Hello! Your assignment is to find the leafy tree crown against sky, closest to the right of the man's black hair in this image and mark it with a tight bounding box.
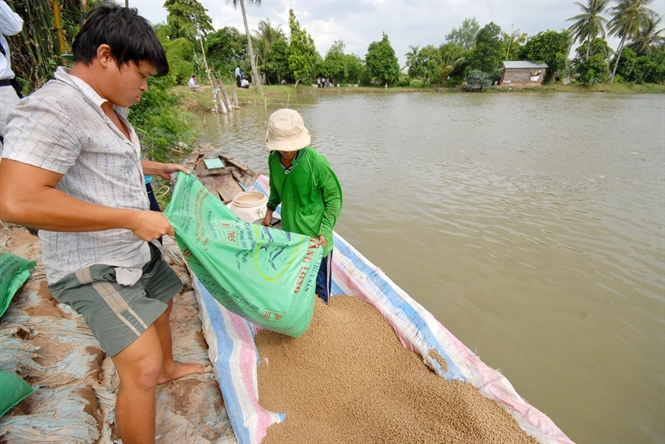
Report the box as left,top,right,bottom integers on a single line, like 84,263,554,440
164,0,213,42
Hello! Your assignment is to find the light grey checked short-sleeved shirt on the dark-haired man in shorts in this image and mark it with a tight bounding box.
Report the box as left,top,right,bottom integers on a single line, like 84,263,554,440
2,67,150,284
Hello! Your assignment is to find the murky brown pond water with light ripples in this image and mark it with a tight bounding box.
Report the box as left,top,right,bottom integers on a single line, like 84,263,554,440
193,93,665,442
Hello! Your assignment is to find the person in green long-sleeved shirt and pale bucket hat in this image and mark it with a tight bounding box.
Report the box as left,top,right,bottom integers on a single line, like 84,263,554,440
263,109,342,304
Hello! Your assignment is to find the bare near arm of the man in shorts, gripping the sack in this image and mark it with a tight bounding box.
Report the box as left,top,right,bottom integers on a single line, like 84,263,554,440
0,159,174,241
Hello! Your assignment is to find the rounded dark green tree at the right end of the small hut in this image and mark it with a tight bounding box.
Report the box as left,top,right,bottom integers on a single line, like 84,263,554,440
520,30,571,82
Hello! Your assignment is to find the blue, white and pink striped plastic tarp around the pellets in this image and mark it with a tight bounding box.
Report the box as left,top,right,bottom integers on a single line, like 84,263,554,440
193,176,572,444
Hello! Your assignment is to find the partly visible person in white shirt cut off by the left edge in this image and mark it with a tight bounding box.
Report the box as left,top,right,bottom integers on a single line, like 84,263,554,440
0,0,23,138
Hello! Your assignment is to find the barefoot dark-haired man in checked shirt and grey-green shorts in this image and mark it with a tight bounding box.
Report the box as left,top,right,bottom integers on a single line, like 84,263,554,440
0,2,203,444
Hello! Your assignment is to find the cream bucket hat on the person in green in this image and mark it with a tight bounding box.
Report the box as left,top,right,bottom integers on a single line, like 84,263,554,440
266,108,312,151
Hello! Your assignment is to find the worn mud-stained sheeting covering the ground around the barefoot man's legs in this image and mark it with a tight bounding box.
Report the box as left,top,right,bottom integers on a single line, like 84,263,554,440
0,225,237,444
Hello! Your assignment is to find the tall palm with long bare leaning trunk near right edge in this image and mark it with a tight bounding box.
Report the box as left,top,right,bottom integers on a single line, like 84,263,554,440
608,0,658,83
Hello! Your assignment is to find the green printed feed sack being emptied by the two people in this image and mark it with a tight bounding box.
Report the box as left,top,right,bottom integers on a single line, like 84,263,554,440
165,172,322,338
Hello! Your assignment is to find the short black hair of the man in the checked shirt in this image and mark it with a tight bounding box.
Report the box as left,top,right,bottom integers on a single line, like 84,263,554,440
72,2,169,77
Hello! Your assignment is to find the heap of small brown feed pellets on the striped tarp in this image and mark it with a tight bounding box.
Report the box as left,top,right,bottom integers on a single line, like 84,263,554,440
256,296,536,444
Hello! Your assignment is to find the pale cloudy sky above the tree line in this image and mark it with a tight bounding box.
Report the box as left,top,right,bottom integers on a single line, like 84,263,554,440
128,0,665,66
